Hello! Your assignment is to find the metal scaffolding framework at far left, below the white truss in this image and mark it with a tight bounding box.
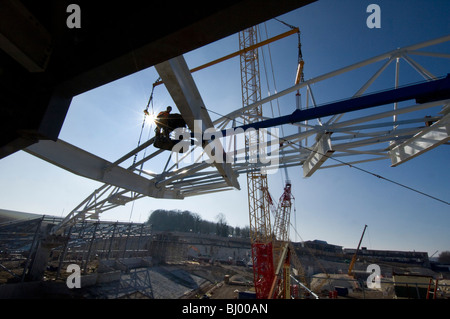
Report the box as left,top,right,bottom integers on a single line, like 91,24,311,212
0,216,153,284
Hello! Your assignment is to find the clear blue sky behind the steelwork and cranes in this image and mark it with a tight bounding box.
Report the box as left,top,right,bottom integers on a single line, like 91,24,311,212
0,0,450,254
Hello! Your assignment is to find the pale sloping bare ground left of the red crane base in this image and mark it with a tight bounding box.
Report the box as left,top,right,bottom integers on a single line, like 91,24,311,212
78,261,253,299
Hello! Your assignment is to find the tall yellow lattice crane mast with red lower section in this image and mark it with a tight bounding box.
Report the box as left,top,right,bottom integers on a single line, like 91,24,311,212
239,26,274,299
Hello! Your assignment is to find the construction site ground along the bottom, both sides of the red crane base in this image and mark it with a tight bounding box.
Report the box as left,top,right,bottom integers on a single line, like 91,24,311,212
0,221,450,299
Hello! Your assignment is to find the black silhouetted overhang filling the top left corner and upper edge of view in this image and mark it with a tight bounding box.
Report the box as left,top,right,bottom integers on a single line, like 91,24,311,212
0,0,316,158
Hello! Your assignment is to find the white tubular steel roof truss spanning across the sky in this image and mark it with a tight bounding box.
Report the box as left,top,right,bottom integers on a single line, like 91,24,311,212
27,35,450,233
